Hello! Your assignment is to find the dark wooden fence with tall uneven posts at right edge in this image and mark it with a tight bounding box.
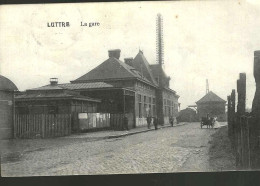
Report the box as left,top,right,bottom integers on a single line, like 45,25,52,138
228,73,260,169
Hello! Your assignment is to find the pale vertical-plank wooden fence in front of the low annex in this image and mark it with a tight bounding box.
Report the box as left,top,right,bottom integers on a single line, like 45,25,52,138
14,114,71,138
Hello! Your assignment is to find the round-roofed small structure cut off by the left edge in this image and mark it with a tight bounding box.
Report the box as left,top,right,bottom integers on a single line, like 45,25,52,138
0,75,18,140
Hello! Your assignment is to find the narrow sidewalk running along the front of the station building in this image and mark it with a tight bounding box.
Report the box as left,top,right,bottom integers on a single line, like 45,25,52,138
62,122,187,140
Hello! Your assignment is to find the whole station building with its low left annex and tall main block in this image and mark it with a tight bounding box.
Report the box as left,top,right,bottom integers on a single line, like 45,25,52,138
16,49,179,128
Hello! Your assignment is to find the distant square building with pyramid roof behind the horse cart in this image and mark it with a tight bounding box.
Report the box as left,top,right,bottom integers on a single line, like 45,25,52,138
196,91,227,121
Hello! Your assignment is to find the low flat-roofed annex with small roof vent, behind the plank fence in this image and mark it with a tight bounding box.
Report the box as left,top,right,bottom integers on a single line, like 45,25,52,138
15,78,101,132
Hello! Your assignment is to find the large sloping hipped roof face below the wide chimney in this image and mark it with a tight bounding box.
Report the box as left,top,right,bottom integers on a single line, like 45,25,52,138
72,57,138,83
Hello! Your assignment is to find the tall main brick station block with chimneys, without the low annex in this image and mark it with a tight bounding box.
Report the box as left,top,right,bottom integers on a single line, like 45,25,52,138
71,49,179,127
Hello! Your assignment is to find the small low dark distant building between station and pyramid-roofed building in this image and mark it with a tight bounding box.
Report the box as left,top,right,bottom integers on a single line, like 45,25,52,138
177,107,199,122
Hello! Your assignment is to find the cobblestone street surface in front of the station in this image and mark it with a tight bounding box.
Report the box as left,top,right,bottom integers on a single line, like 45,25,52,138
1,123,224,176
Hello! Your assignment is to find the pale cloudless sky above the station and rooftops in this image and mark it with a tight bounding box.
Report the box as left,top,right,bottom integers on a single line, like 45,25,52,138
0,0,260,109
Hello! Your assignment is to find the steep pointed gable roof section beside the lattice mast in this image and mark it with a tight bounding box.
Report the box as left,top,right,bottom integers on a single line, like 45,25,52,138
132,51,157,85
